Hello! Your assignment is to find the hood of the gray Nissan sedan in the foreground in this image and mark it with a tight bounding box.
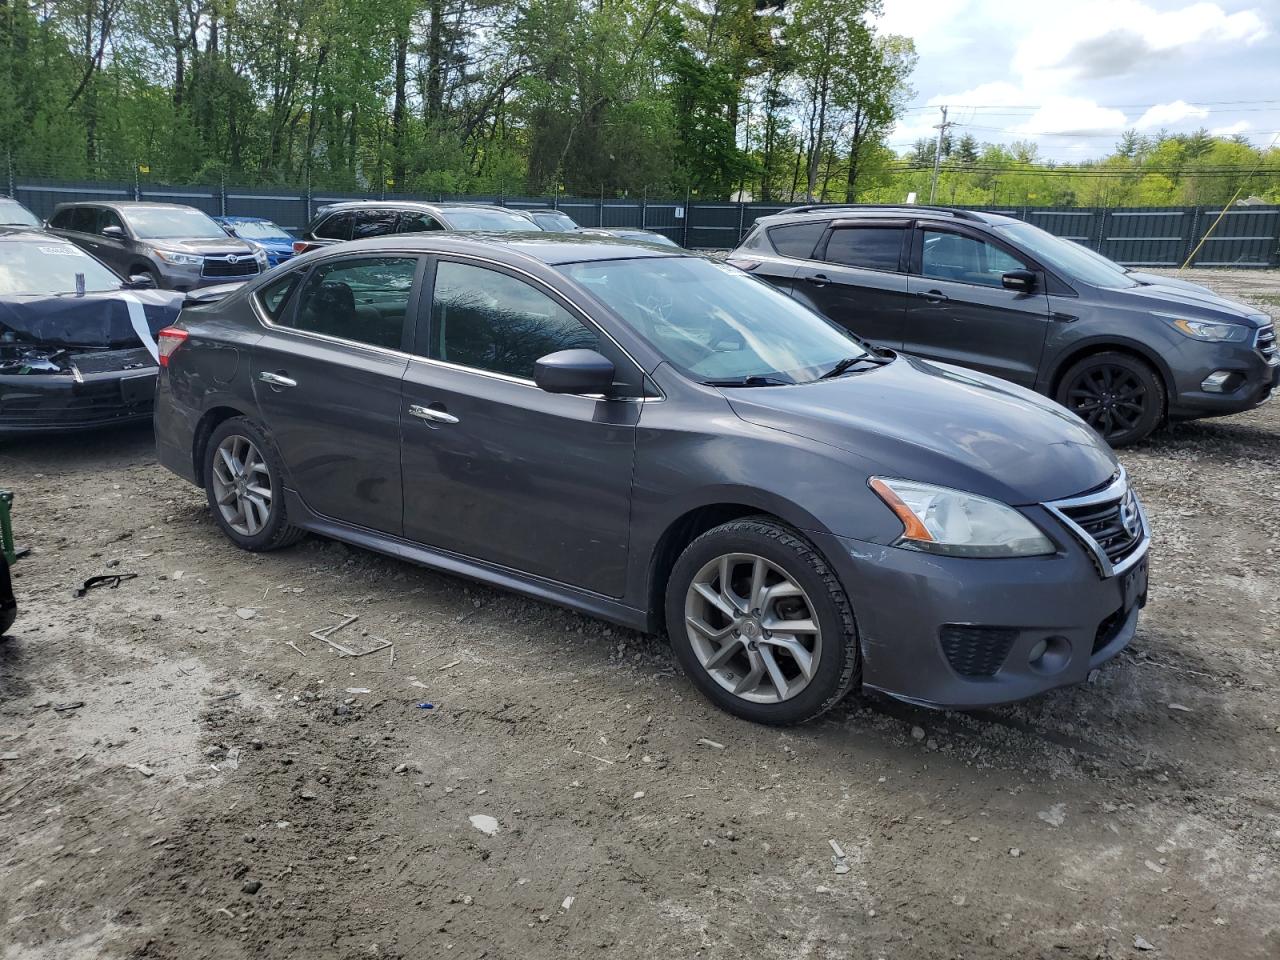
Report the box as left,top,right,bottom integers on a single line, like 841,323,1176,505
722,356,1120,506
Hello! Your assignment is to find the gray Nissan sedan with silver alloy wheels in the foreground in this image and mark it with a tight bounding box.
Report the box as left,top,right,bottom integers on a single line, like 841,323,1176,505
155,234,1148,723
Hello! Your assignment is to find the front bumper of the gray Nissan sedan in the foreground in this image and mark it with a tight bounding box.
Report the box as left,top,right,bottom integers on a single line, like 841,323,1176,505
819,522,1149,709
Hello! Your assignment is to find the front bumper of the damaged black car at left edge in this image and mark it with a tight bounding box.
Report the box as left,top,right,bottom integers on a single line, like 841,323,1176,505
0,366,156,438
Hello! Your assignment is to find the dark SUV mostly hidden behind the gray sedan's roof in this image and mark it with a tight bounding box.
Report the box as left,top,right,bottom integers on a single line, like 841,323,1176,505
293,200,541,253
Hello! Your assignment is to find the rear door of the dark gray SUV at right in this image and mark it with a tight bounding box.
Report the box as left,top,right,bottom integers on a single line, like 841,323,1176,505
794,219,911,349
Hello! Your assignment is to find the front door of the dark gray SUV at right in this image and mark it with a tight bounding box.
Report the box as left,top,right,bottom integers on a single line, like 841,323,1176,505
902,223,1048,387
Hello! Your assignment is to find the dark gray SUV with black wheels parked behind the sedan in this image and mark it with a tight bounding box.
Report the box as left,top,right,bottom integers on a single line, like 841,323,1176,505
730,206,1280,447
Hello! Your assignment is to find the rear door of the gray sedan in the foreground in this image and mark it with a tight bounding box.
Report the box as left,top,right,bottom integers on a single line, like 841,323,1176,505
241,255,422,535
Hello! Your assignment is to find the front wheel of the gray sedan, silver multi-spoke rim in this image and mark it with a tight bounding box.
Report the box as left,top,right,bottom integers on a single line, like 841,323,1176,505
666,517,861,726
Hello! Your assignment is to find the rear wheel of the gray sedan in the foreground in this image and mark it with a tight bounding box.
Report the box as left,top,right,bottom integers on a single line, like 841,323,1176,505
204,417,303,552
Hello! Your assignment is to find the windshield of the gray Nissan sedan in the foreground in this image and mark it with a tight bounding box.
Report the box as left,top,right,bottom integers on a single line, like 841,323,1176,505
561,257,870,383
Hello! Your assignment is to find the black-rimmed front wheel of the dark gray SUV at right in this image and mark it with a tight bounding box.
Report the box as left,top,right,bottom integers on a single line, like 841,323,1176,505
1056,351,1165,448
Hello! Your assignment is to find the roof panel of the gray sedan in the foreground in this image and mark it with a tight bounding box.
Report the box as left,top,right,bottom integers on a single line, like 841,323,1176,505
307,230,692,266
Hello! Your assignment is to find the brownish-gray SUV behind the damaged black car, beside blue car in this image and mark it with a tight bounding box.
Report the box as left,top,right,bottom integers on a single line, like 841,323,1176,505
49,201,268,291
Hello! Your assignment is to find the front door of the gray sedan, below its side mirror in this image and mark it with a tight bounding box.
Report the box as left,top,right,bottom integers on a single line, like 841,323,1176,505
401,259,643,596
